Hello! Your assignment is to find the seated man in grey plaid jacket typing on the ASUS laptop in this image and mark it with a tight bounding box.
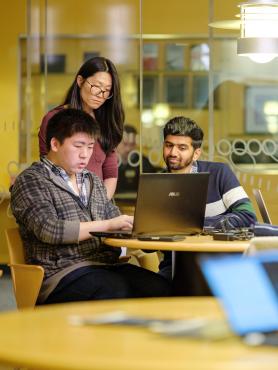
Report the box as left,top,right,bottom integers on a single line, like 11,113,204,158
11,109,170,304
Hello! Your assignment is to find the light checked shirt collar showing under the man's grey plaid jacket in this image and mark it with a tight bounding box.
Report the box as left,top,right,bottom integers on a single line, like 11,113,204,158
41,157,89,206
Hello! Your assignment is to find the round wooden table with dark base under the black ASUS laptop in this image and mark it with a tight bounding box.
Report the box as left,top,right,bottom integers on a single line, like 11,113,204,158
104,235,249,296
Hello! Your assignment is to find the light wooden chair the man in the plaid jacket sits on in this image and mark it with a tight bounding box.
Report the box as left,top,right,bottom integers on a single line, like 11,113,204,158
5,228,44,309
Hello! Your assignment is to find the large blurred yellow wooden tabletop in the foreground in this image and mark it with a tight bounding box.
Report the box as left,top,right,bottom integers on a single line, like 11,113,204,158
0,298,278,370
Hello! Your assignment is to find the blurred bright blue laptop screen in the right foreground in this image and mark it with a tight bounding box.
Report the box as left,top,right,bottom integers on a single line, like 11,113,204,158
200,252,278,335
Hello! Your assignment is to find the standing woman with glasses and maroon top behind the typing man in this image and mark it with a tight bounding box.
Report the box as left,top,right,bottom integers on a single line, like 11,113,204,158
39,57,124,199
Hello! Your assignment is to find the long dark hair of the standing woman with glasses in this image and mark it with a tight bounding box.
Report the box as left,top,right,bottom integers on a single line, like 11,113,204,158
63,57,125,153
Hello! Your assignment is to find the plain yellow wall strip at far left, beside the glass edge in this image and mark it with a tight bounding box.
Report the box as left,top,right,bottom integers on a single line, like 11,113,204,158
0,0,25,192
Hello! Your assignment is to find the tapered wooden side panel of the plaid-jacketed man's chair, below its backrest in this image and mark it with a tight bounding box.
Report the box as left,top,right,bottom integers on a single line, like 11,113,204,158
9,264,44,309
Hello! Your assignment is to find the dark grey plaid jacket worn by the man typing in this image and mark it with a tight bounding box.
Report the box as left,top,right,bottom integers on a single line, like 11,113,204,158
11,162,120,278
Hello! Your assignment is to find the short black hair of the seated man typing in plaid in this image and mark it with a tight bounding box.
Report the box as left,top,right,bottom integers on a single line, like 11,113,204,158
46,108,99,151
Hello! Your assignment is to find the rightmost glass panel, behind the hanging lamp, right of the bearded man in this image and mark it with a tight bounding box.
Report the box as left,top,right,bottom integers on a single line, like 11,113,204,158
210,0,278,223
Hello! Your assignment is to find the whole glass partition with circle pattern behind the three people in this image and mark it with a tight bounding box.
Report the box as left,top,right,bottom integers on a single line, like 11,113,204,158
16,0,278,221
